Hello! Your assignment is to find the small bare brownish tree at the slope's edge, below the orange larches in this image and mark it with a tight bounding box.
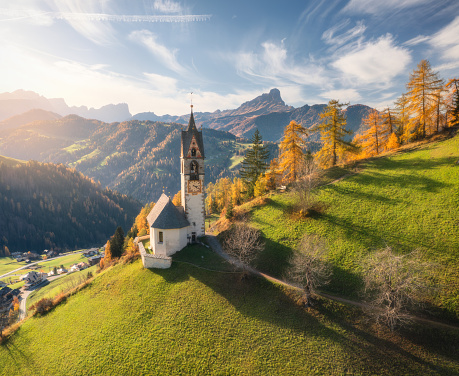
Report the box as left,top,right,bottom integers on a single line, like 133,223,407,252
293,155,322,217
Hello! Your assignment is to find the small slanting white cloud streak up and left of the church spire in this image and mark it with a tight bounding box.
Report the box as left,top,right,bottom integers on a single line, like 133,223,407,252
129,30,186,75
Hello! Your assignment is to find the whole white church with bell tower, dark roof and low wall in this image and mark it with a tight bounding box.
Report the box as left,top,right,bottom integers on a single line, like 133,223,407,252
139,107,205,268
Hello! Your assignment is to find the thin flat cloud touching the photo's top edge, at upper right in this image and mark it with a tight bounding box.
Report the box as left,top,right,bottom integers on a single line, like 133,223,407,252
343,0,430,15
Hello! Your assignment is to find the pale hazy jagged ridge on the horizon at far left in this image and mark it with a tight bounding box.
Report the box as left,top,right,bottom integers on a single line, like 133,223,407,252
0,90,132,122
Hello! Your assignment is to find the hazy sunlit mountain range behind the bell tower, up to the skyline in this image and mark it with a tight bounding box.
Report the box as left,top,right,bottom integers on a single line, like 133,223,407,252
0,89,371,203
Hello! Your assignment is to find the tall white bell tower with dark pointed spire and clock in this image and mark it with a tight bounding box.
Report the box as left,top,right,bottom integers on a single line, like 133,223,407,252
180,105,205,242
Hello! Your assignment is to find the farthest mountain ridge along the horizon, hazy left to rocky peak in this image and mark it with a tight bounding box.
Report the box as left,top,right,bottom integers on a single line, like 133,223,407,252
0,88,372,143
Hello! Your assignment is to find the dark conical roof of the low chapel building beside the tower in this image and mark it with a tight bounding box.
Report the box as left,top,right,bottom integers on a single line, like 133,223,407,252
147,193,190,230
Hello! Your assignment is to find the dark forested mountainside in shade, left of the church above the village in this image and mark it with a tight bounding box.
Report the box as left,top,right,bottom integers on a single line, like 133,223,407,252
0,158,141,253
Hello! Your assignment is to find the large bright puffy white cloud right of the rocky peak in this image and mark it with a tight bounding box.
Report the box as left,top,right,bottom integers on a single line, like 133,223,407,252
332,34,411,84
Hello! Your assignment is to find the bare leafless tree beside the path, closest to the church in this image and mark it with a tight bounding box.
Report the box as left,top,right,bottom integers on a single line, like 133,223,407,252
223,223,264,270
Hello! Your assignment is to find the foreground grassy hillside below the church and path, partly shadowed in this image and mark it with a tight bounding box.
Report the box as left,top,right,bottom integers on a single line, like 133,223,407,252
0,246,459,376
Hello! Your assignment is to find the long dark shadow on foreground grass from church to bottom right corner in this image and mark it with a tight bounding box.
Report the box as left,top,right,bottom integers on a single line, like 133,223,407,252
152,264,454,375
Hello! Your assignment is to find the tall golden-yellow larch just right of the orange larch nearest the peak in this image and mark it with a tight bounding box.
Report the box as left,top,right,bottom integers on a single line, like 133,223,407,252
314,99,354,167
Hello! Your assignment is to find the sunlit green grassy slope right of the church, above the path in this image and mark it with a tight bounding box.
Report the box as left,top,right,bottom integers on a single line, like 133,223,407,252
246,137,459,317
